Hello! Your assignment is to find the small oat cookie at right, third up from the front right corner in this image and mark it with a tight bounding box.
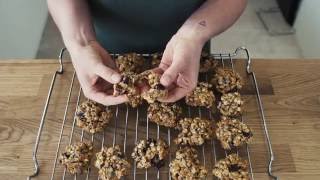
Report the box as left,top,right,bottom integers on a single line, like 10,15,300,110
218,92,244,117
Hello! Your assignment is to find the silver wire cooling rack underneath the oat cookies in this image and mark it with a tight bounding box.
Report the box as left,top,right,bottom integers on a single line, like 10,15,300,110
27,47,277,180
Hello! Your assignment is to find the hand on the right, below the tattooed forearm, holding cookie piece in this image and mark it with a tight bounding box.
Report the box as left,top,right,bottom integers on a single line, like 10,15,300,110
159,35,203,102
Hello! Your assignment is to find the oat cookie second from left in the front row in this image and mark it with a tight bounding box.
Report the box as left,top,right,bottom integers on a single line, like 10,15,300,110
95,145,130,180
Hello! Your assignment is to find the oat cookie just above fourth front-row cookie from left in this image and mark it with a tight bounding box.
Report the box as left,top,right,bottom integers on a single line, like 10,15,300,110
174,117,213,145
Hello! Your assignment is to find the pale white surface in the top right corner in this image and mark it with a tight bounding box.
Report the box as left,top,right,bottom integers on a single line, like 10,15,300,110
294,0,320,58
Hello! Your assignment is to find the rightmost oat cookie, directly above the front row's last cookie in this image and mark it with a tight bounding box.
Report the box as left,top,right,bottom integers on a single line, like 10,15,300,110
216,118,253,149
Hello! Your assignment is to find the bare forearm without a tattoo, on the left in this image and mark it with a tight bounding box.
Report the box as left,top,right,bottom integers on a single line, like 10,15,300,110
47,0,95,48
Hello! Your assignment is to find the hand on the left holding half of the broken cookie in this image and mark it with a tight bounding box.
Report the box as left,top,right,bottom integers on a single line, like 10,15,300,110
68,41,127,106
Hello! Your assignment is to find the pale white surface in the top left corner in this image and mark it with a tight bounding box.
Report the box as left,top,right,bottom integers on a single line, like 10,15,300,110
0,0,48,59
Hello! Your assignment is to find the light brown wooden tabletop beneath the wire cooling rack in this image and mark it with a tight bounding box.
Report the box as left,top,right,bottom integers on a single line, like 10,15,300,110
0,59,320,180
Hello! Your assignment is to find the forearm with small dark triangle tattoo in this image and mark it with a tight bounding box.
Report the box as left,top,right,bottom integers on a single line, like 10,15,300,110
177,0,247,44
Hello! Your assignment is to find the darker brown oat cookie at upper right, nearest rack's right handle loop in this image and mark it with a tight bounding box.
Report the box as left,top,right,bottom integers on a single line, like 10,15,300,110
211,68,243,94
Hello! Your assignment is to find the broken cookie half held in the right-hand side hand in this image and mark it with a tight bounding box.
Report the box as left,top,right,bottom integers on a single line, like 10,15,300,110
141,71,168,103
